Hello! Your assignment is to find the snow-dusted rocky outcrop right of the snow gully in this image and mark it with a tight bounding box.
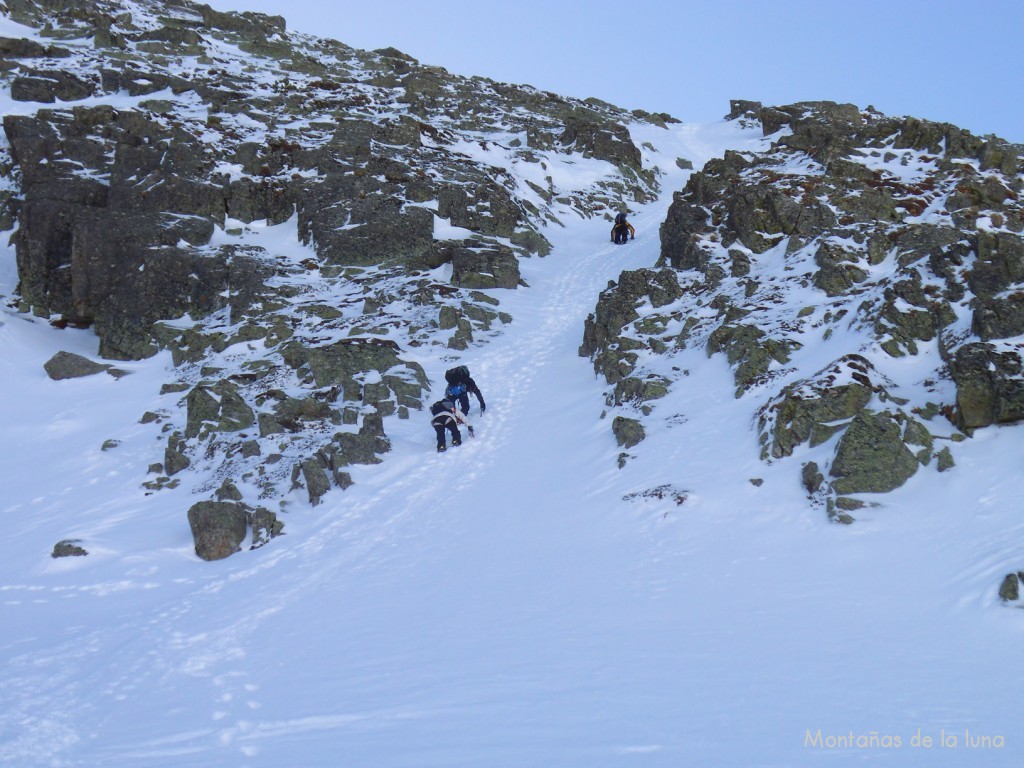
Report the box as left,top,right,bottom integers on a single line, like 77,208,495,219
580,101,1024,512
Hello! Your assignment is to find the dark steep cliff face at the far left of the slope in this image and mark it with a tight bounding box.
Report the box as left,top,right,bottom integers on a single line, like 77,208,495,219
4,108,267,359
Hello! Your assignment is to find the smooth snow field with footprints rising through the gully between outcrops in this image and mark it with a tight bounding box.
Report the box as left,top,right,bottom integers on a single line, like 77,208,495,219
0,114,1024,768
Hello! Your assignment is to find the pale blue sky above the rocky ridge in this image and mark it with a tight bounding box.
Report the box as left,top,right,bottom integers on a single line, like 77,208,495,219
208,0,1024,142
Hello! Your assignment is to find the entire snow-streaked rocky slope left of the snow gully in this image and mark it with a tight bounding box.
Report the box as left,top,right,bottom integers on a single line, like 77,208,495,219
0,0,669,557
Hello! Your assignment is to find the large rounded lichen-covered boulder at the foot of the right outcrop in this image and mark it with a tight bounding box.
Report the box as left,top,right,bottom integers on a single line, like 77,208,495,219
829,412,919,495
